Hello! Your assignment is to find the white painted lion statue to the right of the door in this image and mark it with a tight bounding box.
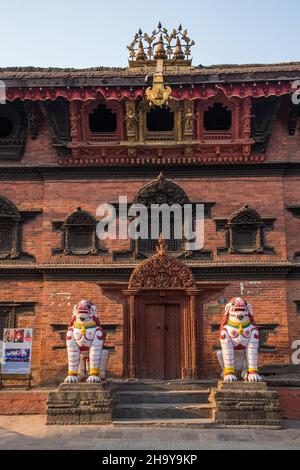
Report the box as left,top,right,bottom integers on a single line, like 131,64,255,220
218,298,263,382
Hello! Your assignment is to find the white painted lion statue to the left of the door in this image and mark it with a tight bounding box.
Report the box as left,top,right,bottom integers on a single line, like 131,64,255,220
65,300,108,384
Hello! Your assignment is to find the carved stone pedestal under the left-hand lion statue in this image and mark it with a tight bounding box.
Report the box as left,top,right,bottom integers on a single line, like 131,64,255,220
47,383,113,425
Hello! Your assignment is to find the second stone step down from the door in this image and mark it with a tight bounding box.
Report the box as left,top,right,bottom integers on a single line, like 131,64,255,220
115,389,210,405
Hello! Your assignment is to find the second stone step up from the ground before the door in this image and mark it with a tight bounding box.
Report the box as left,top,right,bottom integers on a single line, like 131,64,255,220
113,403,212,420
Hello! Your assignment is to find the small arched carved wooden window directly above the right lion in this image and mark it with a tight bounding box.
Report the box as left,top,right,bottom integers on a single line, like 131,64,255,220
226,206,264,254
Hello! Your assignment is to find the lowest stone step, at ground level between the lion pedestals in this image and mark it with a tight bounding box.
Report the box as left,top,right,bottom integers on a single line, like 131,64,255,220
113,418,214,429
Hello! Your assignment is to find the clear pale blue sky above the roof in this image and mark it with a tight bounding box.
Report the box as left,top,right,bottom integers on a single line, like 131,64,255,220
0,0,300,67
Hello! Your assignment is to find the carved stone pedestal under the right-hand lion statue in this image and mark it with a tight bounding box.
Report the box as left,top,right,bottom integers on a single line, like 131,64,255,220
210,382,281,426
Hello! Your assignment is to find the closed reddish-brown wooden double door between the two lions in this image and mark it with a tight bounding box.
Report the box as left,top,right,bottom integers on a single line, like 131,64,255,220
138,297,184,380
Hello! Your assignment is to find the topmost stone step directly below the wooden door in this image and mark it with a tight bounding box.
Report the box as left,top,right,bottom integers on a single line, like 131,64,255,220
107,380,217,392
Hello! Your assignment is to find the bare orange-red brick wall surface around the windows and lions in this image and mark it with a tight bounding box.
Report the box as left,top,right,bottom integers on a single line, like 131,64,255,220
0,105,300,383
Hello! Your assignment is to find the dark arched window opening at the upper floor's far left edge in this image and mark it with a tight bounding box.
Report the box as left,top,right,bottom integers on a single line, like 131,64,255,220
0,100,27,161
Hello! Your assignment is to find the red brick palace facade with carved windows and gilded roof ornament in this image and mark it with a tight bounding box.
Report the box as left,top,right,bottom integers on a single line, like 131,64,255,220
0,26,300,384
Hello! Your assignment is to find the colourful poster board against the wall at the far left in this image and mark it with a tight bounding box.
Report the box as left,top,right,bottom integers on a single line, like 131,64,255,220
2,328,32,374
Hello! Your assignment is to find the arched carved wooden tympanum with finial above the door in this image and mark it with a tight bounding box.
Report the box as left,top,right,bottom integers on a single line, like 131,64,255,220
129,237,196,290
